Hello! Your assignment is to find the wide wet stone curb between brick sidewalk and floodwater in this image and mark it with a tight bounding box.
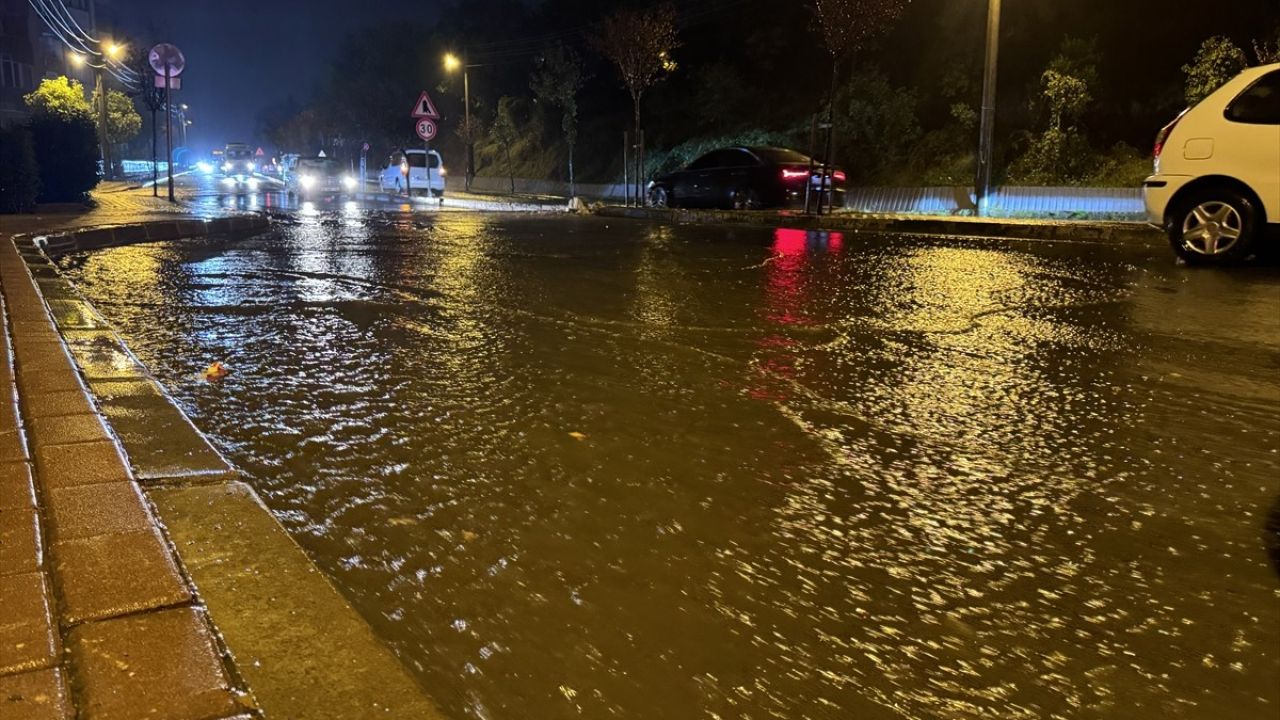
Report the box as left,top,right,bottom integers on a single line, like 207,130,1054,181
8,221,443,720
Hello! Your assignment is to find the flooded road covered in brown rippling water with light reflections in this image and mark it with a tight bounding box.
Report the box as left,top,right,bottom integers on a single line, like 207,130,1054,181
63,211,1280,719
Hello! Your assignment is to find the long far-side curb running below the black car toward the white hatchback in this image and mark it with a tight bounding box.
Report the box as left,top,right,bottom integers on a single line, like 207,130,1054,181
594,206,1165,245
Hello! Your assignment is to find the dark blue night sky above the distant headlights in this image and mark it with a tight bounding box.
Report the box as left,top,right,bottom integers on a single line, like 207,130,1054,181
111,0,435,151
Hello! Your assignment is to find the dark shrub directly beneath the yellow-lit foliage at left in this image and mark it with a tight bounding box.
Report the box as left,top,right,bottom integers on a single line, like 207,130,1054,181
31,114,99,202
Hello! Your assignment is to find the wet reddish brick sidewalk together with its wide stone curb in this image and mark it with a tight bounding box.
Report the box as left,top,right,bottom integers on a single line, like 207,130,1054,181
0,218,440,720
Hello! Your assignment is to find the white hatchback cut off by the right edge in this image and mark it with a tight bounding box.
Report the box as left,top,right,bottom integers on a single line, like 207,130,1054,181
1142,63,1280,264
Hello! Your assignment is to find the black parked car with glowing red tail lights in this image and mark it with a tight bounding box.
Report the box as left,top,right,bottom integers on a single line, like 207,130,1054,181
649,147,845,210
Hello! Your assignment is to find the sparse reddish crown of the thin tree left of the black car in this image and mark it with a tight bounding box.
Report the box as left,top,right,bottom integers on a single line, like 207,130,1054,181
594,3,680,196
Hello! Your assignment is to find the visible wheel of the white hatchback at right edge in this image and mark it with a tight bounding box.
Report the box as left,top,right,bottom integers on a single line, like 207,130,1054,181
1166,187,1258,265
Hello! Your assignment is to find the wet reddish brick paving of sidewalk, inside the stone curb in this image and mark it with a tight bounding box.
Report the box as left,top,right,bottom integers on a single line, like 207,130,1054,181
0,204,255,720
